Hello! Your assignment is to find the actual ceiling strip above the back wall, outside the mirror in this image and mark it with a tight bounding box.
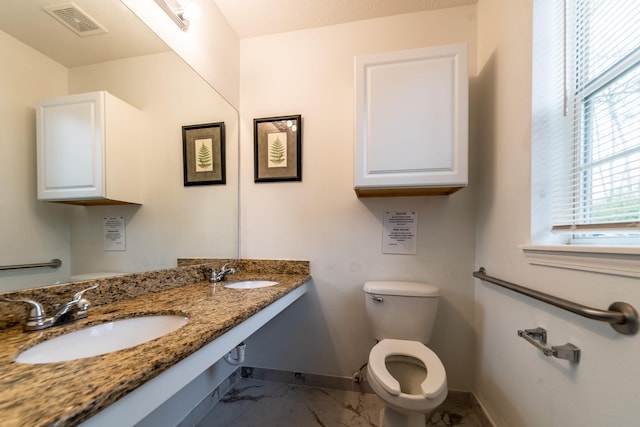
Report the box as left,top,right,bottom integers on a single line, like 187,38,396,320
212,0,478,38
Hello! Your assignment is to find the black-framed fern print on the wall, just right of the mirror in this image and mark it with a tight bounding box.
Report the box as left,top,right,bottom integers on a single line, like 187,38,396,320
253,114,302,182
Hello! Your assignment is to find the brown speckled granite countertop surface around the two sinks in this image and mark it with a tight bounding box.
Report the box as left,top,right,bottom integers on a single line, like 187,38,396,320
0,264,310,427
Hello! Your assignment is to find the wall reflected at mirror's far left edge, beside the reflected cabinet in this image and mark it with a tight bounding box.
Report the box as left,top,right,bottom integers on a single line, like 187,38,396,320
0,31,71,292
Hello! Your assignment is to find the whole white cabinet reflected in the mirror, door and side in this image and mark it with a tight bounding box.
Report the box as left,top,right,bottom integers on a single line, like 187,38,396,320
36,91,142,205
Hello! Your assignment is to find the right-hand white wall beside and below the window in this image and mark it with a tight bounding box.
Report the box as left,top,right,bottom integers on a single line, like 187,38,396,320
474,0,640,427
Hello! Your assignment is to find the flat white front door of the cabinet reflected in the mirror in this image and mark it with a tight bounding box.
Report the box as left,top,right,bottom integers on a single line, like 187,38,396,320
36,92,104,200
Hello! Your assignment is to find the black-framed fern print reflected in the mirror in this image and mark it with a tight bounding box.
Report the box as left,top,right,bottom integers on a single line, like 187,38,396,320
182,122,227,186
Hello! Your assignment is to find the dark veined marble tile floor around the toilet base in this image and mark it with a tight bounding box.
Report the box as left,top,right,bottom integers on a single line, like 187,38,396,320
196,378,482,427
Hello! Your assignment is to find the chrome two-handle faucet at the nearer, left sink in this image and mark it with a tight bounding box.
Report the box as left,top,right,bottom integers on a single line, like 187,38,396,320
0,283,98,332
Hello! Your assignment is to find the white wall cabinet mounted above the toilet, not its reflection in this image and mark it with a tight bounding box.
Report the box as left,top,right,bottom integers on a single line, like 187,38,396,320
354,44,469,197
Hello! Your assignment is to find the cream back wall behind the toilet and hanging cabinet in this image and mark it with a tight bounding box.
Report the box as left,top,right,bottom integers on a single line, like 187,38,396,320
240,6,476,390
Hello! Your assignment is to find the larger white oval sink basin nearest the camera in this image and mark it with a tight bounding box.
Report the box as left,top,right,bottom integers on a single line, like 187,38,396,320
15,315,189,364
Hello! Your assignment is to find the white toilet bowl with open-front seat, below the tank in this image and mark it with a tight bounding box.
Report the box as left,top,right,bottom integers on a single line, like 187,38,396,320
368,339,447,427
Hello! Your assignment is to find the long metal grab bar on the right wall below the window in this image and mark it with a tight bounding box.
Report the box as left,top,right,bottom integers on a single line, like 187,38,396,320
473,267,640,335
